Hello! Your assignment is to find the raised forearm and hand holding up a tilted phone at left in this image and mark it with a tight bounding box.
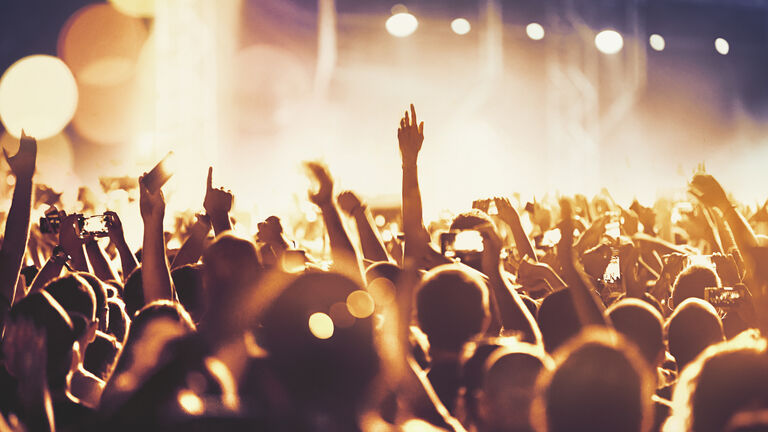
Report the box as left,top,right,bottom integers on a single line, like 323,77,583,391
139,177,176,303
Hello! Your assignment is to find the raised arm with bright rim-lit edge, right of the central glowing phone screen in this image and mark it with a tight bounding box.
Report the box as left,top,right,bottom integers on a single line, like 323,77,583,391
477,224,541,344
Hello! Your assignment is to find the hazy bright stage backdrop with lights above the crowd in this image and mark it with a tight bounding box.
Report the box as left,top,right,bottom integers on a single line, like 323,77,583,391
0,0,768,223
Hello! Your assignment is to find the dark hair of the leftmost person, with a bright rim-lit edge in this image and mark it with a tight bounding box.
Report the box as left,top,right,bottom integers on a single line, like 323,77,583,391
3,290,77,390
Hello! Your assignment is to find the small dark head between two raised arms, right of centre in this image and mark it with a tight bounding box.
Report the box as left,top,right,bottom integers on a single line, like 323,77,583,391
536,289,580,353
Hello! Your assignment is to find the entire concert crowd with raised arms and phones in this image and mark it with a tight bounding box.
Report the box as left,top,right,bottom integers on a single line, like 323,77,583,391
0,105,768,432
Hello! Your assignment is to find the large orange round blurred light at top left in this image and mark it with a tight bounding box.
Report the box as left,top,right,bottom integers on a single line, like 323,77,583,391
57,3,148,86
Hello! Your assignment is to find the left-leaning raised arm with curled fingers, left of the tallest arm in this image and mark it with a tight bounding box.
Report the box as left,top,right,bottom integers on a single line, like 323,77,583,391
306,162,362,280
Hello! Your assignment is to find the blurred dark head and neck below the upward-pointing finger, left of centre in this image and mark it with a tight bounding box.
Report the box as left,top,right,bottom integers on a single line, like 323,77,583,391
200,233,262,339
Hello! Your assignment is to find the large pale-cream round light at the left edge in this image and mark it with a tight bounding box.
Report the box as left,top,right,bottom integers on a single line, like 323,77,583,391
0,55,78,139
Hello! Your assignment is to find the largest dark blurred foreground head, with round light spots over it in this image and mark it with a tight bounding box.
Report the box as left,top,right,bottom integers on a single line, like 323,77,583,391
254,273,379,409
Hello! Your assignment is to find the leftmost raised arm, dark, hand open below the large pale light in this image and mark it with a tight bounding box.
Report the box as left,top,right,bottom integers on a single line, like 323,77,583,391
0,131,37,312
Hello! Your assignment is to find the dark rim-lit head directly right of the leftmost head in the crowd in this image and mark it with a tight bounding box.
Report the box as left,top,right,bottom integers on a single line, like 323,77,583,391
45,274,98,354
